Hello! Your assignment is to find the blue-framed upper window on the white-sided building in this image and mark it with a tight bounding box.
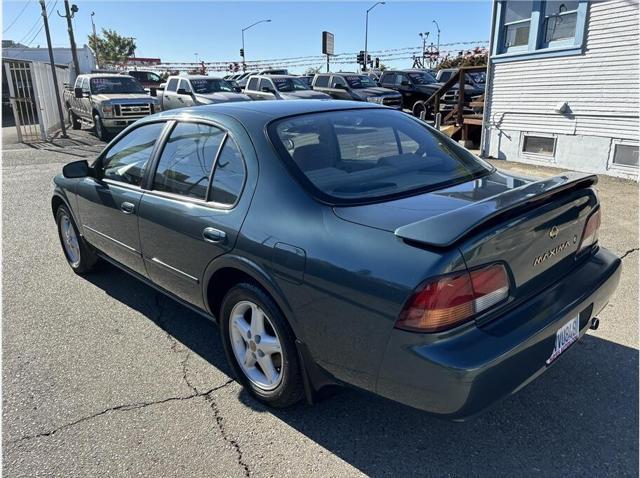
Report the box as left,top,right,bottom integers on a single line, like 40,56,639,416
492,0,588,63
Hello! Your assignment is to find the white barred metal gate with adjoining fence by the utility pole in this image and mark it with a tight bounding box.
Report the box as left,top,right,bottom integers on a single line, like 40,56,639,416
4,59,69,143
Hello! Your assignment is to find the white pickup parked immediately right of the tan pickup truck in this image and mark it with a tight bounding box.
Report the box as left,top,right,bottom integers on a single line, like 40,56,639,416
162,75,251,110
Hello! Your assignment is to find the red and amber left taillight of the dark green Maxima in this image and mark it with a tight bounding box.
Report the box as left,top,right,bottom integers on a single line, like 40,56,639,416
396,264,509,332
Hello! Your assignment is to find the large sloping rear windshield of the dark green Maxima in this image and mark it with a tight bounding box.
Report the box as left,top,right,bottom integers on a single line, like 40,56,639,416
269,108,493,204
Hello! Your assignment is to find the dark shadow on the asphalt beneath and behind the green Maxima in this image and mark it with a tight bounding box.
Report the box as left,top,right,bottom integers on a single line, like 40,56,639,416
87,265,638,477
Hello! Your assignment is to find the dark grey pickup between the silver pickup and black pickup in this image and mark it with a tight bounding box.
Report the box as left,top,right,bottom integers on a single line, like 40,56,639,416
313,72,402,109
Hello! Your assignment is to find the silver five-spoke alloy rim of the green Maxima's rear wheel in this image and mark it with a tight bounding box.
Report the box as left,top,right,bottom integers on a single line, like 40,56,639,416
229,301,283,390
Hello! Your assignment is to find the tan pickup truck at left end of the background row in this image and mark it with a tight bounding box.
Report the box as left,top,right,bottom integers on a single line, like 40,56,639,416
64,73,160,141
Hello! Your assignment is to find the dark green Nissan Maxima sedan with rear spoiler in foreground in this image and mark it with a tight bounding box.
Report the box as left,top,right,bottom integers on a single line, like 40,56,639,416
51,100,621,419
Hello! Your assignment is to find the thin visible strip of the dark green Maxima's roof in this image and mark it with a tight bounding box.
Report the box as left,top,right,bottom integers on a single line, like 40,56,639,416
151,99,388,124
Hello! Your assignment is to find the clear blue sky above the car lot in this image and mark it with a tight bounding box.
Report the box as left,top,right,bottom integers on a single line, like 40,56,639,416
3,0,491,70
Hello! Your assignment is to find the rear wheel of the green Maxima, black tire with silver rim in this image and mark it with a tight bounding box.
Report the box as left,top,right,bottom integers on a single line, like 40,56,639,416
220,283,304,408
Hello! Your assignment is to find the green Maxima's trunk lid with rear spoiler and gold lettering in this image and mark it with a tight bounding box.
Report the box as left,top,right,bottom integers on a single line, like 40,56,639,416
336,172,598,298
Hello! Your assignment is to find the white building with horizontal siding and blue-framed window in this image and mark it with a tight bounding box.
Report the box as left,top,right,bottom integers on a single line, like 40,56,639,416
481,0,640,177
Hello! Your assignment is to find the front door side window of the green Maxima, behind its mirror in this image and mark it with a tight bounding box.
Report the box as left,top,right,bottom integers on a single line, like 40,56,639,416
102,123,165,186
